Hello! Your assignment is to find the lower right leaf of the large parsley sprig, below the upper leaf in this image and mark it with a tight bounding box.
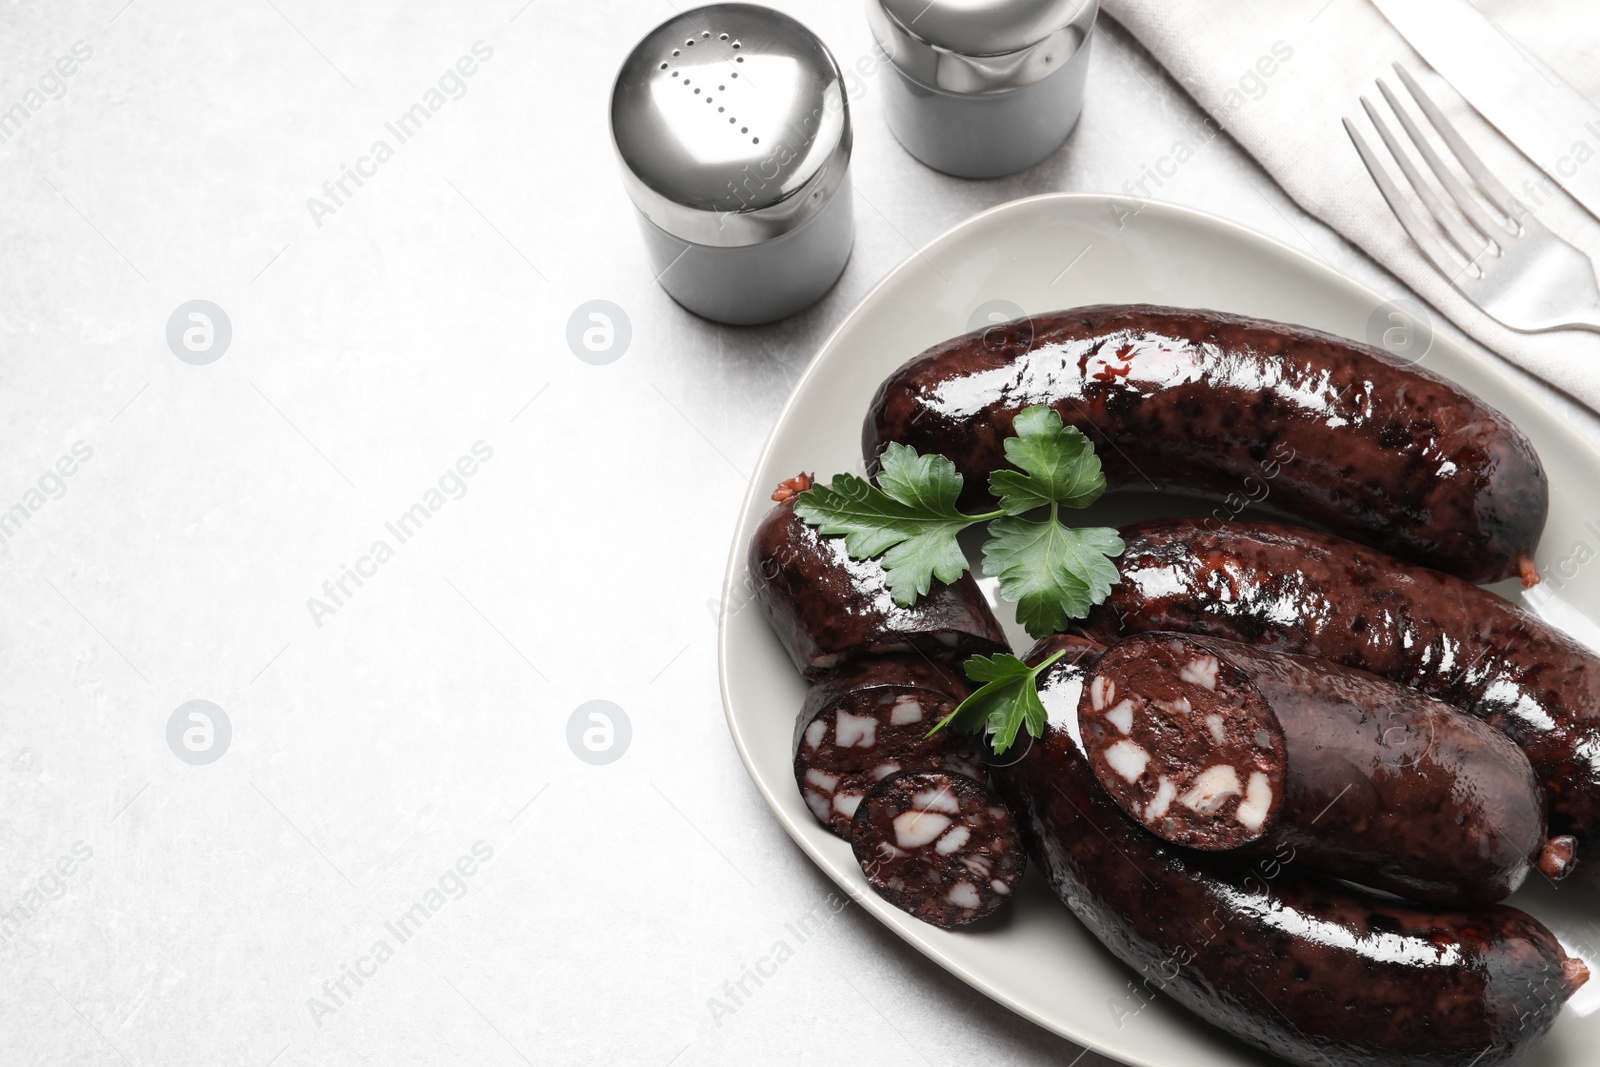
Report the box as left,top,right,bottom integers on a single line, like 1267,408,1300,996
984,518,1125,637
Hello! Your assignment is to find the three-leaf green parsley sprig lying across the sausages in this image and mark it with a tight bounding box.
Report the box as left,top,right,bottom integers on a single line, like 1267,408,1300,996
795,406,1123,637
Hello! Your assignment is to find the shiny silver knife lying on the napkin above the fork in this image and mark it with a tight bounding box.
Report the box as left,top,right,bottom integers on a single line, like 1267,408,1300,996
1373,0,1600,219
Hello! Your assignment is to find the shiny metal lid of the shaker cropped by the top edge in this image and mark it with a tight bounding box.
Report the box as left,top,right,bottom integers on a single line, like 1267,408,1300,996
867,0,1099,93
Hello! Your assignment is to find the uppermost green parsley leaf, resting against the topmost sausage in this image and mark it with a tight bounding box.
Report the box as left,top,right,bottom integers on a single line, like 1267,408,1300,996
989,406,1106,515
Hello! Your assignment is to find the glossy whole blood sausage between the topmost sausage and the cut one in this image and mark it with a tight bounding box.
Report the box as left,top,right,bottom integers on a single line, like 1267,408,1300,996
1082,520,1600,880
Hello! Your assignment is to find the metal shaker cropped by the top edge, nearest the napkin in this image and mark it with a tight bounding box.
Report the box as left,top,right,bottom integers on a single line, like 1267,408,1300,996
867,0,1099,178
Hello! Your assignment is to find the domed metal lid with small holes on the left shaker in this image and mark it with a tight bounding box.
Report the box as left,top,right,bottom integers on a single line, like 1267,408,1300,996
611,3,851,246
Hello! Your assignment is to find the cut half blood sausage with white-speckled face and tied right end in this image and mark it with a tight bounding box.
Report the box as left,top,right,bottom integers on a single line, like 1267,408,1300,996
1078,633,1573,907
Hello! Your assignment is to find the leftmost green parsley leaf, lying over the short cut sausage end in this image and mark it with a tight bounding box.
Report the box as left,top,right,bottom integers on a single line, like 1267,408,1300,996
795,443,1000,605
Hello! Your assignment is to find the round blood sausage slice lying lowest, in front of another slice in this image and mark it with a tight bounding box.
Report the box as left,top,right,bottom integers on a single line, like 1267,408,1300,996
850,771,1027,929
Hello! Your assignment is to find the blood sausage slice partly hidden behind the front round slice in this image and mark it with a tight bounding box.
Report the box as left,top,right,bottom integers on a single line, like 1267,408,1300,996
795,656,986,840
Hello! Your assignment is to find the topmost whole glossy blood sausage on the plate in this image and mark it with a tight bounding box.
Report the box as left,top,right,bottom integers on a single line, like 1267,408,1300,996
862,306,1549,584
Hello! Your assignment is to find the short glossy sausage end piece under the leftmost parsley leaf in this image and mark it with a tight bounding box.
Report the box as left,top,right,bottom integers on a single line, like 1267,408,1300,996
749,480,1008,678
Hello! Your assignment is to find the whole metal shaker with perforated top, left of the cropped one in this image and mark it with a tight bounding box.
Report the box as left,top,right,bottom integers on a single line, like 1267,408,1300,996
611,3,854,325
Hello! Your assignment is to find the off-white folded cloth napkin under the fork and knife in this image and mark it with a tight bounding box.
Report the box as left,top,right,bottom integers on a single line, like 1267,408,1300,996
1104,0,1600,411
